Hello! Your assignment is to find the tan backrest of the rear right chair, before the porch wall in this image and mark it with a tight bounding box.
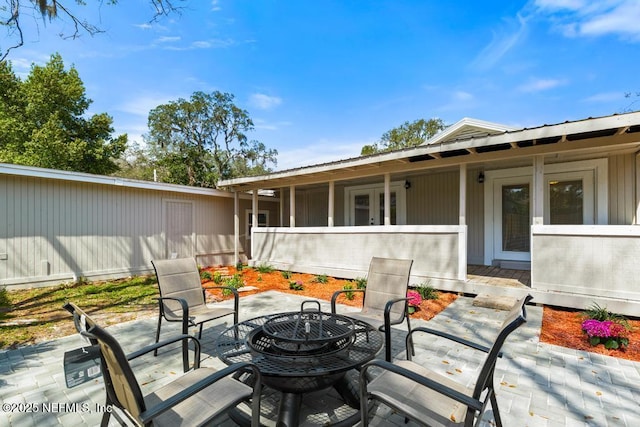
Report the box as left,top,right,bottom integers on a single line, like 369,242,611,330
362,257,413,320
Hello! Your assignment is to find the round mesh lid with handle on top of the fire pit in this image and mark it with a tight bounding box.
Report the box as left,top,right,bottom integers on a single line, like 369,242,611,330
262,300,355,343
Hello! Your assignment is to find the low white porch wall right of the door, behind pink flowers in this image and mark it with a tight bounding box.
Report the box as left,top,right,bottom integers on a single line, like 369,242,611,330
531,225,640,316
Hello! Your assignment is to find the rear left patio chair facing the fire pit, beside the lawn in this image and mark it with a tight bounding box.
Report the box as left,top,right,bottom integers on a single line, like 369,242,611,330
151,258,239,362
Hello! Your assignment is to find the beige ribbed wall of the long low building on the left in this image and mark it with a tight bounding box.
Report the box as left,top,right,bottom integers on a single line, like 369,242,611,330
0,174,273,287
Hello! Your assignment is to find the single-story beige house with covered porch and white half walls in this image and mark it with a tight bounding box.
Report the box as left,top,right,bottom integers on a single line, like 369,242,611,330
218,112,640,316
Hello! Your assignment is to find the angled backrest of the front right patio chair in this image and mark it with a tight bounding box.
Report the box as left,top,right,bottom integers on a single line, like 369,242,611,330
473,295,533,399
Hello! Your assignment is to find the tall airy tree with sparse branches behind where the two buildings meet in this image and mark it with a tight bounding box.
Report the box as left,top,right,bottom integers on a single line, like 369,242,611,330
145,91,278,187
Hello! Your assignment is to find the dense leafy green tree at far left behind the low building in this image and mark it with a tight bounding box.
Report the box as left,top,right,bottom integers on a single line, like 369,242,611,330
0,54,127,174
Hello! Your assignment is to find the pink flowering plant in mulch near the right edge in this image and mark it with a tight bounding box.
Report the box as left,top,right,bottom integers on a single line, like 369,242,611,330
582,303,630,349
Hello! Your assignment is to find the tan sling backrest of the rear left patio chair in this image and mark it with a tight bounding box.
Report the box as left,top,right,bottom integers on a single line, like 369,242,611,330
151,258,205,316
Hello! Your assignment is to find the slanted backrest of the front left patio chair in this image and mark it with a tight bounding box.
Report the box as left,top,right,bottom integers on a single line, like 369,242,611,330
64,303,145,418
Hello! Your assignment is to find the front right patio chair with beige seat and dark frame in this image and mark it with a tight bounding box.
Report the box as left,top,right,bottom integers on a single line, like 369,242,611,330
360,295,531,427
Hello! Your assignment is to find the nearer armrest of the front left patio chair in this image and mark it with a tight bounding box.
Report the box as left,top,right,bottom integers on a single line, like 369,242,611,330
139,362,262,425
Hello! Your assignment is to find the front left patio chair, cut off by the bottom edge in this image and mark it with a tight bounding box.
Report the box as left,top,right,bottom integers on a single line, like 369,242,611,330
64,303,261,427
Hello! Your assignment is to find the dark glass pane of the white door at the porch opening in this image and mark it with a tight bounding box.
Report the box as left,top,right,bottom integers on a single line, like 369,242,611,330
502,184,531,252
